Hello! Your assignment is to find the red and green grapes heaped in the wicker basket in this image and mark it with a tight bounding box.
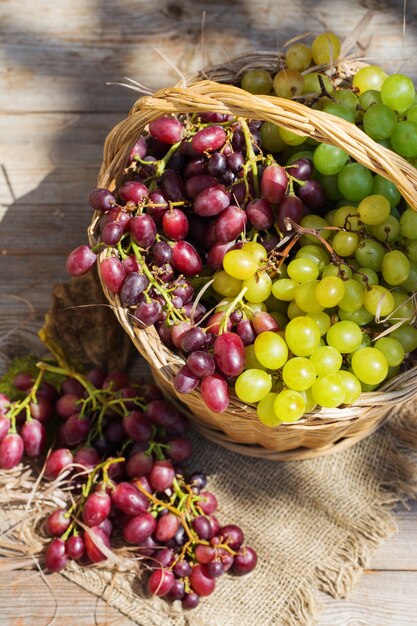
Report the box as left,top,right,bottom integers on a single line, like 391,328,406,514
67,33,417,426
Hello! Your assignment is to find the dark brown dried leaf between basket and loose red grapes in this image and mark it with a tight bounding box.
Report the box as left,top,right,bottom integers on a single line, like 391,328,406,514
39,271,134,370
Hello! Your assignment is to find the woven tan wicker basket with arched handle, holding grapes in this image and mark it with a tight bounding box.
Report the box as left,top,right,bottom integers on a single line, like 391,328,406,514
89,53,417,460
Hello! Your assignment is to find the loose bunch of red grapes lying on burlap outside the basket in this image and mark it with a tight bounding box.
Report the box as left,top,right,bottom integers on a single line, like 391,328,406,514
0,363,257,609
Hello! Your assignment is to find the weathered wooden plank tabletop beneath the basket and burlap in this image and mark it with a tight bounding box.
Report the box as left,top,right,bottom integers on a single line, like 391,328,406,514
0,0,417,626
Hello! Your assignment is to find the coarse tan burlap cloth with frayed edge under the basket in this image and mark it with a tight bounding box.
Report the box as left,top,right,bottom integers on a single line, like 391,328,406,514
0,320,417,626
